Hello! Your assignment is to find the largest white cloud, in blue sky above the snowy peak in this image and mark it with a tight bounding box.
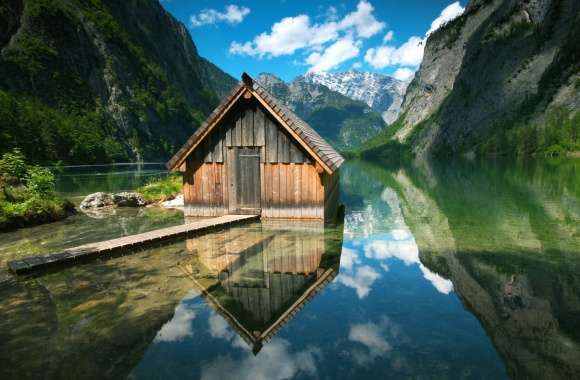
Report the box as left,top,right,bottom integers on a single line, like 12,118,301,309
229,0,385,71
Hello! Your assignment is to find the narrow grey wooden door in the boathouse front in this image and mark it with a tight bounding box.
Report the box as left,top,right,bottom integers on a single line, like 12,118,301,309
230,147,262,215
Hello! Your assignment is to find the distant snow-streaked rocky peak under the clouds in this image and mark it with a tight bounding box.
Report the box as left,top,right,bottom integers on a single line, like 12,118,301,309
304,70,409,124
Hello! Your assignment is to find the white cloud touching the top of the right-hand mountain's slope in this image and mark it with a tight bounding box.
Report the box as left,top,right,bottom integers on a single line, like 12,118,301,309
365,1,465,73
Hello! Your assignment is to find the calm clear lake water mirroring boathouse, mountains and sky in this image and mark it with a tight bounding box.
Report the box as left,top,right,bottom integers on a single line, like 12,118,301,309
0,161,580,379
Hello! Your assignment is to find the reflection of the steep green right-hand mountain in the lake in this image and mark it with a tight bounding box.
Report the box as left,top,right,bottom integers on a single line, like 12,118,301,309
362,162,580,379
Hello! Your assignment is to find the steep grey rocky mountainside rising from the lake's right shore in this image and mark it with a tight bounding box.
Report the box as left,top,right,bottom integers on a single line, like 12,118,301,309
361,0,580,156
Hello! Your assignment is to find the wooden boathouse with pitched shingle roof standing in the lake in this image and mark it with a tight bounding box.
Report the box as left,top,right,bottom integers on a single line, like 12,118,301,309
167,73,344,220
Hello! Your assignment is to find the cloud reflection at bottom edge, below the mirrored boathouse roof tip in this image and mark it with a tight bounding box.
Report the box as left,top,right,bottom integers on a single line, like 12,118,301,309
201,338,319,380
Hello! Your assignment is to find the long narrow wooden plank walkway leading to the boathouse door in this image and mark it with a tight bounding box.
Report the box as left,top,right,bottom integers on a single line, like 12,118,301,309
8,215,259,274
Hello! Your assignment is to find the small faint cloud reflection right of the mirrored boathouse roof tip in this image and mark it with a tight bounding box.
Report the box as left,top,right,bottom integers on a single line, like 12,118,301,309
348,316,401,365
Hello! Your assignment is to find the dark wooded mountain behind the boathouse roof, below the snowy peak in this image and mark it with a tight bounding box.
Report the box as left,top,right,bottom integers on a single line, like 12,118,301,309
256,73,385,149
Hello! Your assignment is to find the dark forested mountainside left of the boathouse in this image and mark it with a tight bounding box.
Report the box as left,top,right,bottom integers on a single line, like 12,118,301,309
0,0,236,163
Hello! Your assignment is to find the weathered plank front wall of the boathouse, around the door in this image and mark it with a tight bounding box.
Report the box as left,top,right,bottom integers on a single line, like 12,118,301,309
184,101,338,219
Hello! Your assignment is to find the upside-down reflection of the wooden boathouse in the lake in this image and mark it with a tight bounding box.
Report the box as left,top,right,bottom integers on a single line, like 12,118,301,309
181,222,342,353
